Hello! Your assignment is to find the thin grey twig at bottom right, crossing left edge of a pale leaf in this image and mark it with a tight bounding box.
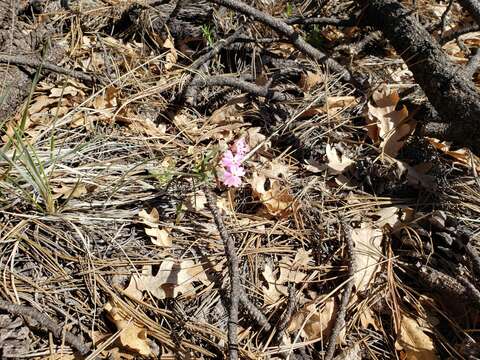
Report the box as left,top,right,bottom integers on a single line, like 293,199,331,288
324,226,355,360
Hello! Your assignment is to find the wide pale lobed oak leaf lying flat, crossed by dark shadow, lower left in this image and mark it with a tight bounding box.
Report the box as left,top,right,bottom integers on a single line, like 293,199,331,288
124,258,210,300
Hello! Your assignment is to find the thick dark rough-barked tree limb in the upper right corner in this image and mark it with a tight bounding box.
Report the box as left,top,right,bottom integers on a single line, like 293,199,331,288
362,0,480,152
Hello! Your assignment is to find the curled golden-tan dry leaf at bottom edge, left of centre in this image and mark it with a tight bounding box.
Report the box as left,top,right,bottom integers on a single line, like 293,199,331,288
104,301,152,356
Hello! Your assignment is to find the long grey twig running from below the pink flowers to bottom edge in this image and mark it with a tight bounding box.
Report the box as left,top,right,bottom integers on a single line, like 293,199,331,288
203,187,241,360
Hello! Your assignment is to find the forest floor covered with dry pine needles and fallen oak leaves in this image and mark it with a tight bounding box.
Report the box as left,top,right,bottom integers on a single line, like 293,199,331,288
0,0,480,360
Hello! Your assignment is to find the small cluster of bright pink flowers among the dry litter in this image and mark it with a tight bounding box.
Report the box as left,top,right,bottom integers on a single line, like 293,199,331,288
220,138,249,187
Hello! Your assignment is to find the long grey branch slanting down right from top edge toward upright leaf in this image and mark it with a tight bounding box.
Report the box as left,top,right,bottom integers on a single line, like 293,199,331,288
210,0,351,81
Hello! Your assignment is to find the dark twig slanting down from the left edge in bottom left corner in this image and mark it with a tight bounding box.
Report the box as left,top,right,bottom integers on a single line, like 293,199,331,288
0,300,90,355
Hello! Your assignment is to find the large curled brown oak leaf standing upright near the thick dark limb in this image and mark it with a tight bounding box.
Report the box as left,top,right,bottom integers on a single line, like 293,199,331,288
367,86,415,157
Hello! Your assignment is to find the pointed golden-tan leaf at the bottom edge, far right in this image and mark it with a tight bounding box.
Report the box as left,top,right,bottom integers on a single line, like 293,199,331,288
395,314,438,360
